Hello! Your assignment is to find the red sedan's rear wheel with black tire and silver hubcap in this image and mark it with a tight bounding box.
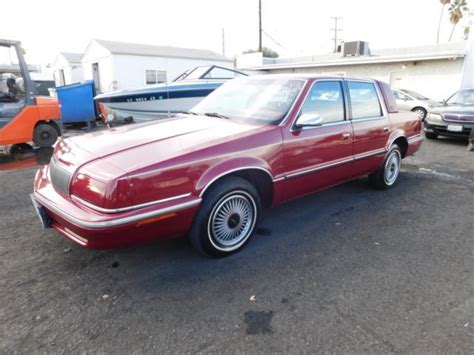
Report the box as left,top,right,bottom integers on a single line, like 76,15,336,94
369,144,402,190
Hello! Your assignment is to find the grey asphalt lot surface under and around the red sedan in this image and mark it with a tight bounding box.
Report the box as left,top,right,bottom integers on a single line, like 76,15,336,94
0,139,474,354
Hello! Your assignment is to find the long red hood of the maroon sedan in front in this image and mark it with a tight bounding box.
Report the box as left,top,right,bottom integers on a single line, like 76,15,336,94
60,115,275,173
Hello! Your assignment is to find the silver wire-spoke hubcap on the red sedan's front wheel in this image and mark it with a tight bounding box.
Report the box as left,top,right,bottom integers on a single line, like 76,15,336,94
208,191,256,251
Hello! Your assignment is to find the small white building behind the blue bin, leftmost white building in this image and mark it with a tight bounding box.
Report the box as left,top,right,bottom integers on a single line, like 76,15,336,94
53,53,83,86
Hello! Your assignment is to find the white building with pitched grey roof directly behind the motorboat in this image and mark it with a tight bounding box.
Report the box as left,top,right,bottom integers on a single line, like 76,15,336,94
81,39,234,92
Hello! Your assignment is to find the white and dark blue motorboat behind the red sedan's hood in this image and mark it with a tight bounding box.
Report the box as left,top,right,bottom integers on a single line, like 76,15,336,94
94,65,247,124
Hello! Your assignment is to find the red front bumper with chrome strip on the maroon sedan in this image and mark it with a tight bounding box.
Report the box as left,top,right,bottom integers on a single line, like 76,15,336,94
31,168,201,249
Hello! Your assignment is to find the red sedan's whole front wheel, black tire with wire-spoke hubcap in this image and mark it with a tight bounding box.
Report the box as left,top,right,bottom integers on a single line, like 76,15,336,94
189,176,262,257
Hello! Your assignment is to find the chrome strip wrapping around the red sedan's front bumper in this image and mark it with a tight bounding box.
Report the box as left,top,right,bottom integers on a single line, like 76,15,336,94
34,193,201,229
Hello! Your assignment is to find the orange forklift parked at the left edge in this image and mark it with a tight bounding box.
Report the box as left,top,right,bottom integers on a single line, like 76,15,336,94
0,39,62,153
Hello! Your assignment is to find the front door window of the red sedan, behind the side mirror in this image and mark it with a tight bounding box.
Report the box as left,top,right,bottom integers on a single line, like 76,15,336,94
301,81,345,123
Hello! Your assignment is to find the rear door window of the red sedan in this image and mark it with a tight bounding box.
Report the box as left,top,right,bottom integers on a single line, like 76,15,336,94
347,81,382,120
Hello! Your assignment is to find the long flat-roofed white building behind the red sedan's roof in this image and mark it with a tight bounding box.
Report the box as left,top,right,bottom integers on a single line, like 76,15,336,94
237,41,472,100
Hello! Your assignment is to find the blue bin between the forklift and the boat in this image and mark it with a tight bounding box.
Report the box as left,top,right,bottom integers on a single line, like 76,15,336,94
56,80,96,123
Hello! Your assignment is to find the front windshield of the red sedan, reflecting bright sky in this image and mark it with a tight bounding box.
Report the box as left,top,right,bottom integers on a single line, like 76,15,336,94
192,78,304,124
